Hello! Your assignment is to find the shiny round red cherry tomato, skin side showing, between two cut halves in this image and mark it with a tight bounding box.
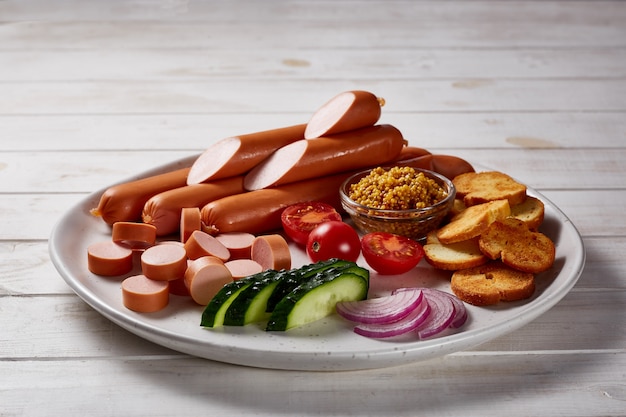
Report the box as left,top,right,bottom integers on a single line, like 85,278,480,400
306,221,361,262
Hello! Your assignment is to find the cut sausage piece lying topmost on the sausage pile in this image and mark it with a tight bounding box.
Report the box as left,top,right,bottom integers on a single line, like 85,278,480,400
304,90,385,139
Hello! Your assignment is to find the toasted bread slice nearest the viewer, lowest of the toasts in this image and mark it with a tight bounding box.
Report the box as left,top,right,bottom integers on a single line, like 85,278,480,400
450,261,535,306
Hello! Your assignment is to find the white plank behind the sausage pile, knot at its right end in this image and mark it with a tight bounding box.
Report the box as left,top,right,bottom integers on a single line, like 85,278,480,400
0,112,626,151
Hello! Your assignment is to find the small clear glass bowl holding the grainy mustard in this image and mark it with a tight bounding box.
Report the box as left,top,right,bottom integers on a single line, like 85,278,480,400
339,168,456,241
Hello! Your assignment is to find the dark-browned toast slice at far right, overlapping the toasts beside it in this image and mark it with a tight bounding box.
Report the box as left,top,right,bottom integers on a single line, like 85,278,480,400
478,217,555,273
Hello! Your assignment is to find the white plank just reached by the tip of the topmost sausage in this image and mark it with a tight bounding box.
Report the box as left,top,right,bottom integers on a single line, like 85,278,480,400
0,79,626,115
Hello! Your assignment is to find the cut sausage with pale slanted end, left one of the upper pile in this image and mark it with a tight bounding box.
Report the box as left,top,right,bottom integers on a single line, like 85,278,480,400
187,124,306,185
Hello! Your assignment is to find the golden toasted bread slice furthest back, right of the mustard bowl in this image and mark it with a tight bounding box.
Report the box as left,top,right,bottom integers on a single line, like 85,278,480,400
452,171,526,206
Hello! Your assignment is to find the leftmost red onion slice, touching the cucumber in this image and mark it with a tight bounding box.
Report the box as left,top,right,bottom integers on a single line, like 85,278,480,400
336,288,423,324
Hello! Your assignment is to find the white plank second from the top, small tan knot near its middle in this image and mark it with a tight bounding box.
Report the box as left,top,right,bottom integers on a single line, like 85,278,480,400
0,47,626,82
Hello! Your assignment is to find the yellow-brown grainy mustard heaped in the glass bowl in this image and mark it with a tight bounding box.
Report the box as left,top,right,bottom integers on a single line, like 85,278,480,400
349,167,447,210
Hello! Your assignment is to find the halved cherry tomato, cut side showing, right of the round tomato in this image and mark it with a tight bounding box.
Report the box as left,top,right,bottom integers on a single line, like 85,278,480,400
361,232,424,275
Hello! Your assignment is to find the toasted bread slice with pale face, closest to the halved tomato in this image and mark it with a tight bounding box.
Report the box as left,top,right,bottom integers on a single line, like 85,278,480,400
424,231,489,271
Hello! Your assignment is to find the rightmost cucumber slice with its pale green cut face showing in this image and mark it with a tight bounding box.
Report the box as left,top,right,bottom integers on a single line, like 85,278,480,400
266,266,369,331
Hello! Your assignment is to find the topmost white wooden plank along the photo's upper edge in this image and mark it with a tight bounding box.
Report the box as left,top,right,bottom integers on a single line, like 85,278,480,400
0,1,626,49
